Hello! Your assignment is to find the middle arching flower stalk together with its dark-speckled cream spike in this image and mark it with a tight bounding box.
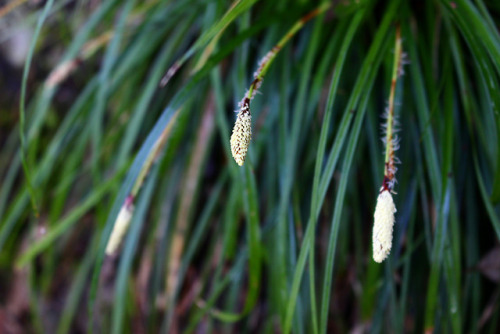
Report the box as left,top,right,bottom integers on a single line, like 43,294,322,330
230,2,331,166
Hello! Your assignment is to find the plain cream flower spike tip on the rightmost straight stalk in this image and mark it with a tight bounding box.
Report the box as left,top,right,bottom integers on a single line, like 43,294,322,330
373,189,396,263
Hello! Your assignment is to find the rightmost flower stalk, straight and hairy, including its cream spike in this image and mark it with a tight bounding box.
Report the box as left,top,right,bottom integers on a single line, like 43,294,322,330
372,25,403,263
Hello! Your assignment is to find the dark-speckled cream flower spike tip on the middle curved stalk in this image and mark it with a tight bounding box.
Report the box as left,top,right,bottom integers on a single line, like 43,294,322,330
231,101,252,166
